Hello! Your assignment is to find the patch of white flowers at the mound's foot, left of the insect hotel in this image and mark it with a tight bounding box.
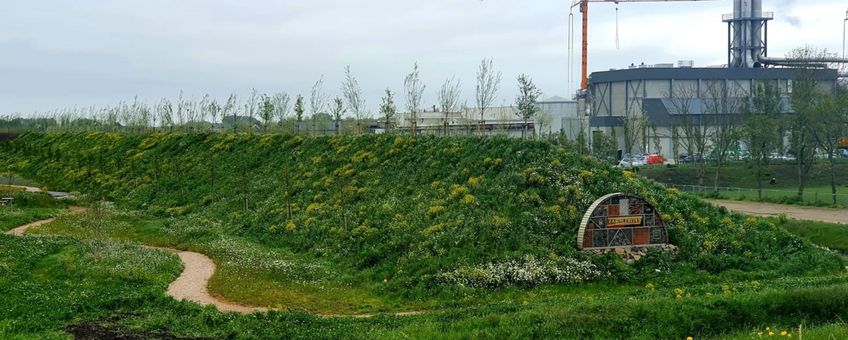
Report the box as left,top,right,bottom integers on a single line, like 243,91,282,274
441,255,609,288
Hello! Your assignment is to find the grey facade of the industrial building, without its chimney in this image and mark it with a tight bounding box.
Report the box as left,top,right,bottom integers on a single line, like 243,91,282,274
587,67,837,159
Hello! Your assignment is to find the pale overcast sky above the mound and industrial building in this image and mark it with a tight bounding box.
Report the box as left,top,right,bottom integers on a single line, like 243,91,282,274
0,0,848,115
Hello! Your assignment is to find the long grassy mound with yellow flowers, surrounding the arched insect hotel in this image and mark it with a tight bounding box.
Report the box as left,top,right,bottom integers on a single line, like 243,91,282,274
0,133,842,292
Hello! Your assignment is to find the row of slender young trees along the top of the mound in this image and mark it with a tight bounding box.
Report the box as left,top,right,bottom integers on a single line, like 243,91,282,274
0,59,540,139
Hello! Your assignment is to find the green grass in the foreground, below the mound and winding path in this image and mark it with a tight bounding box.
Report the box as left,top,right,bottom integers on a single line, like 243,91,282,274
8,230,848,339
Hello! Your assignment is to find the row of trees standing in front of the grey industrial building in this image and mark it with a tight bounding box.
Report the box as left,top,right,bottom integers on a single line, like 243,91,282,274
608,47,848,203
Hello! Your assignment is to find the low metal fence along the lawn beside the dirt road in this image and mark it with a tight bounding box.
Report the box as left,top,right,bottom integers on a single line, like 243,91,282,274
668,184,848,207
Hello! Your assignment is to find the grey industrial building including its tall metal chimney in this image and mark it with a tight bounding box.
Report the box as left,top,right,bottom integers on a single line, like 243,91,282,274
579,0,848,160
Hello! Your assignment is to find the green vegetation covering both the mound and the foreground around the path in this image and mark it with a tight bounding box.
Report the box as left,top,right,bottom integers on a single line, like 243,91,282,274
0,133,848,338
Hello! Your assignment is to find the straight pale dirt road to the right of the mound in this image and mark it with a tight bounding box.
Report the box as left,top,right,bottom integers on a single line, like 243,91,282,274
707,200,848,224
